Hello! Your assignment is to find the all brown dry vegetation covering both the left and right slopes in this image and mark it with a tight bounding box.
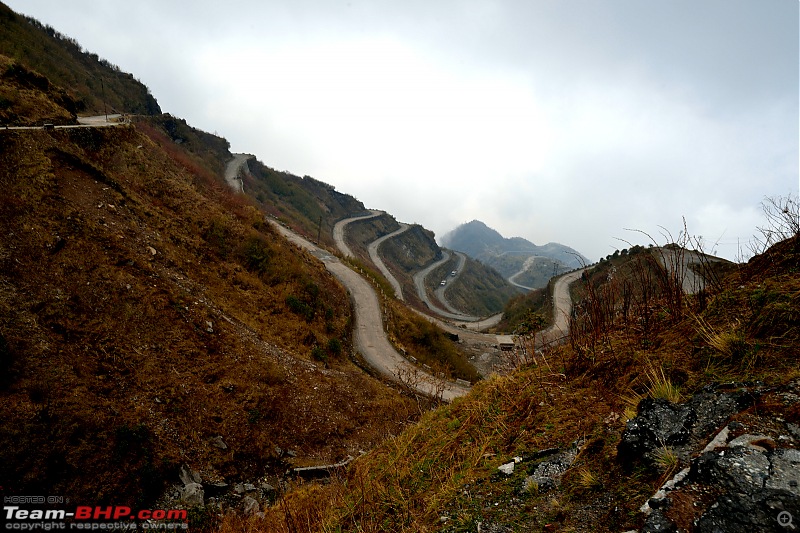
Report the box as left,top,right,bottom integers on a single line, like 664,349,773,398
0,13,800,532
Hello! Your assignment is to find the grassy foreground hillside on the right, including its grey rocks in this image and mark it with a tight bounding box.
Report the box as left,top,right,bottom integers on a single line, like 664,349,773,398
241,235,800,532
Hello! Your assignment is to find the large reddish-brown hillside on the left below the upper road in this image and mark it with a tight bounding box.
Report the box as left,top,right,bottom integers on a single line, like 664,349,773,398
0,54,417,505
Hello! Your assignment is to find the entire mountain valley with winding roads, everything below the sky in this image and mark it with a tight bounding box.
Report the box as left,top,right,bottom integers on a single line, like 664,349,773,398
0,4,800,533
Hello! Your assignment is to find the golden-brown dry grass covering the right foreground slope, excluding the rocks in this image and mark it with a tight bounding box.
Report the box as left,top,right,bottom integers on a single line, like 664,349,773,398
228,227,800,531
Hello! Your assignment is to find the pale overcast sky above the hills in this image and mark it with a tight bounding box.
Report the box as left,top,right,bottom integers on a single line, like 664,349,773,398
4,0,800,260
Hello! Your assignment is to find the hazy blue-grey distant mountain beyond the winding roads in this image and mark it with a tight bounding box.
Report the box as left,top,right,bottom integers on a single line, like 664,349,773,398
441,220,589,287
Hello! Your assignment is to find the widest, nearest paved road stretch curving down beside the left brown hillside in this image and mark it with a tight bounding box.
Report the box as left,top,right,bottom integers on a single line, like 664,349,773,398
268,217,469,401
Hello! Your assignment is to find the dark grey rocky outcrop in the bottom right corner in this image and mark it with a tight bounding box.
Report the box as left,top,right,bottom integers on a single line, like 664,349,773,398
618,381,800,533
